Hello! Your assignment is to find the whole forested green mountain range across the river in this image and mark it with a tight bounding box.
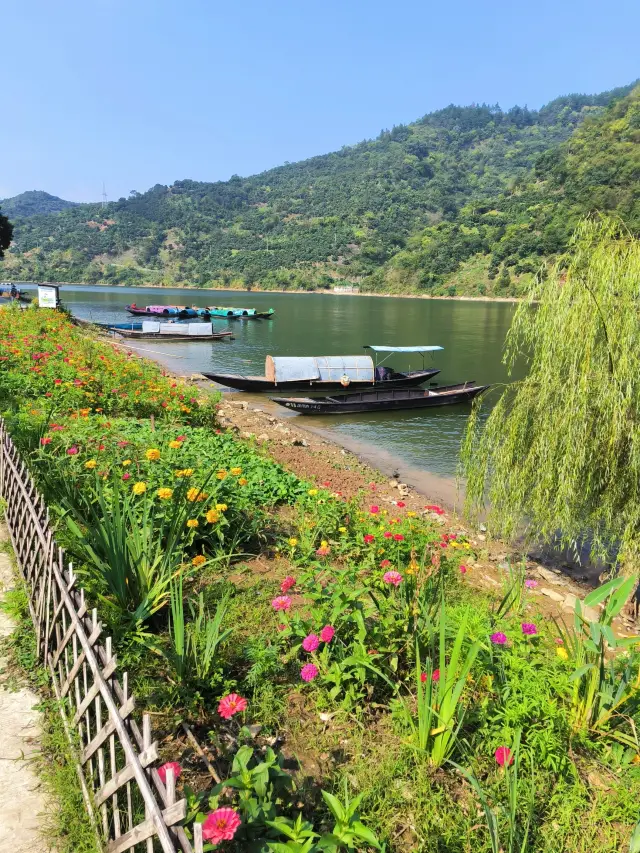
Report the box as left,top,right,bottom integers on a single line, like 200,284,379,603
3,81,639,293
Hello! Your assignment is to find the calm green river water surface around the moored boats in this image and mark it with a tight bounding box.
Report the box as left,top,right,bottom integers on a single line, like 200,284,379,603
23,285,514,476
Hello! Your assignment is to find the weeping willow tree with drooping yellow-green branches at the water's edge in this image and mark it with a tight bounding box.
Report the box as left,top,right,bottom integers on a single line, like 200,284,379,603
461,217,640,564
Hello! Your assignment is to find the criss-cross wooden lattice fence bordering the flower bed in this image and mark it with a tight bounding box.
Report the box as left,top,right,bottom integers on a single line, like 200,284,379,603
0,421,202,853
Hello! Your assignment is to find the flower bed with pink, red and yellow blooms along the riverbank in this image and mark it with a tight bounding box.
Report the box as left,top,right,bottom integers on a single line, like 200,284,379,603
0,310,640,853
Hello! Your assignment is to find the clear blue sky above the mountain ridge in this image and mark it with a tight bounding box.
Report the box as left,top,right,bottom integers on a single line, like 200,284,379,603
0,0,640,201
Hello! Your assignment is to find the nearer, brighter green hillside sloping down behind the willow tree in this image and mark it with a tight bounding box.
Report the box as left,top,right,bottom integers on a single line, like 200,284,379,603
376,86,640,296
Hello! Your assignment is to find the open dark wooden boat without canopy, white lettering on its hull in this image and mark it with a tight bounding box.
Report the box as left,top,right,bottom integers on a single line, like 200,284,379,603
271,380,489,415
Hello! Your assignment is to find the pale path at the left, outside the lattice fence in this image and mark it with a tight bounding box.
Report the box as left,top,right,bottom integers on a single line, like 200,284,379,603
0,524,49,853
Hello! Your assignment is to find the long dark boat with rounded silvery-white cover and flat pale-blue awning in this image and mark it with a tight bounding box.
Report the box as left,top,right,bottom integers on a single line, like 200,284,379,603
203,347,442,392
